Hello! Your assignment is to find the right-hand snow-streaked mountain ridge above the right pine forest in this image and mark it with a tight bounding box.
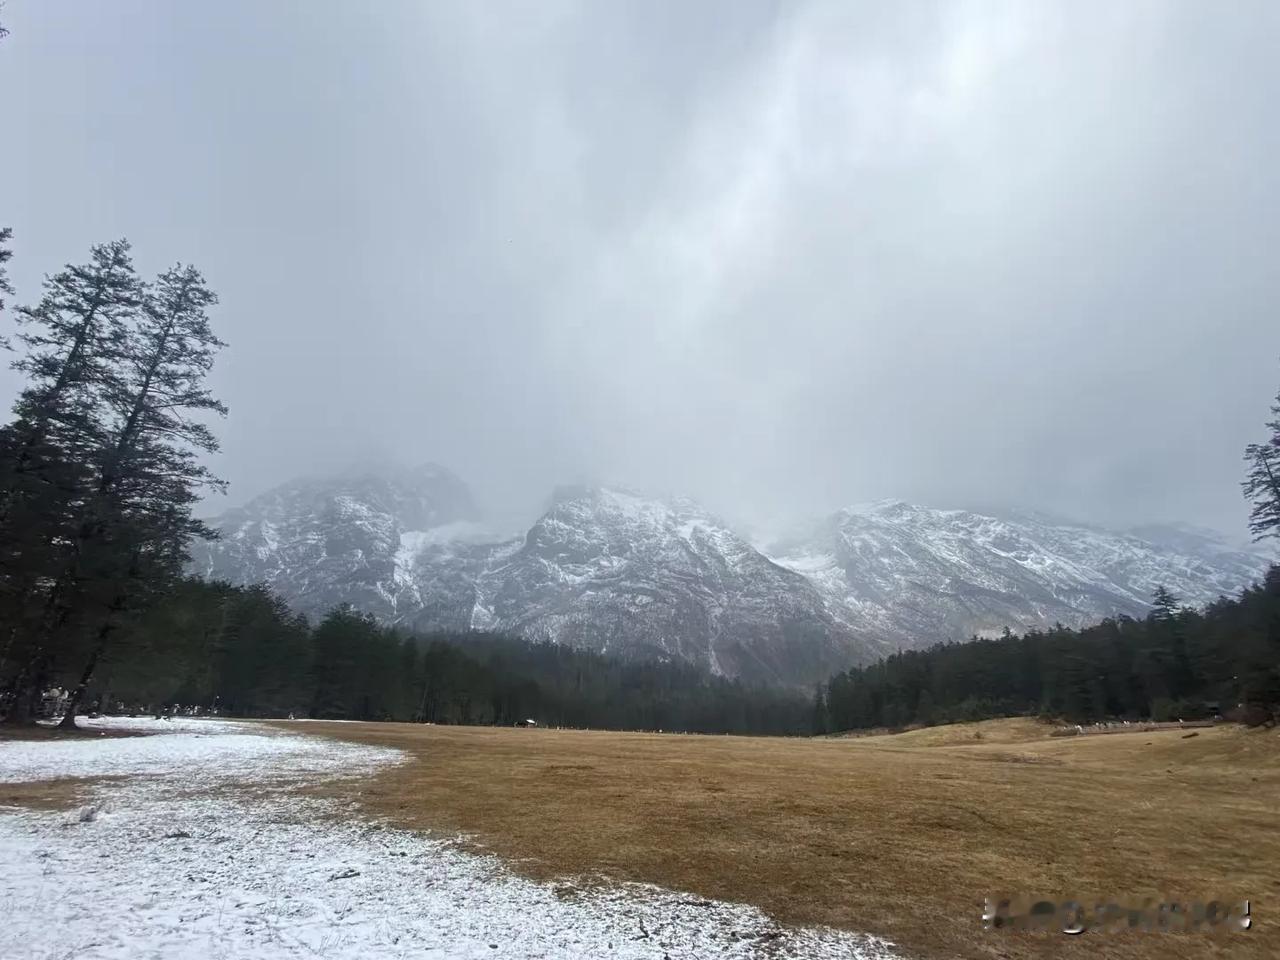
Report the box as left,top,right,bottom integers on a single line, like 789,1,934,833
768,500,1268,646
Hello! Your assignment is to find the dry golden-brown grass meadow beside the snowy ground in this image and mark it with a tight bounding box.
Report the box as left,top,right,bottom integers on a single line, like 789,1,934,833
284,721,1280,960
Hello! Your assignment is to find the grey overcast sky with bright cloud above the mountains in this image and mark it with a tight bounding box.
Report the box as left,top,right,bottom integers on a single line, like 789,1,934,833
0,0,1280,535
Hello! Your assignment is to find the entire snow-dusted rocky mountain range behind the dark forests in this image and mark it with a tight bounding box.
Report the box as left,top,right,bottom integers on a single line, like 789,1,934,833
193,466,1266,685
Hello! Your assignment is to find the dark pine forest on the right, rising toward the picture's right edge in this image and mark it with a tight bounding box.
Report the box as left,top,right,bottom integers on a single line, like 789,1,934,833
817,576,1280,730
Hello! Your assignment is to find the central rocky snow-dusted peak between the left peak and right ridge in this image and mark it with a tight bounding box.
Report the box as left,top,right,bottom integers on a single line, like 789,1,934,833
463,488,874,682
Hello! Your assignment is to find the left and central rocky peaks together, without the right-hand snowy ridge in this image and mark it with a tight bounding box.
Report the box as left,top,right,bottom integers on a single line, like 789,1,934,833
195,478,879,682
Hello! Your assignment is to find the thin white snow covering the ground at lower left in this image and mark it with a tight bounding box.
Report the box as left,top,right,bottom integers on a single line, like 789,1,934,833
0,721,896,960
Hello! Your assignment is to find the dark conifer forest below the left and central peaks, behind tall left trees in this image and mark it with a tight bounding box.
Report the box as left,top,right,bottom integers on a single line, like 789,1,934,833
90,580,809,735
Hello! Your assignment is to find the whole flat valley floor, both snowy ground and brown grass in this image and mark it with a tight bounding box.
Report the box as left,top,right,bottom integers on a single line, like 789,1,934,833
0,719,1280,960
